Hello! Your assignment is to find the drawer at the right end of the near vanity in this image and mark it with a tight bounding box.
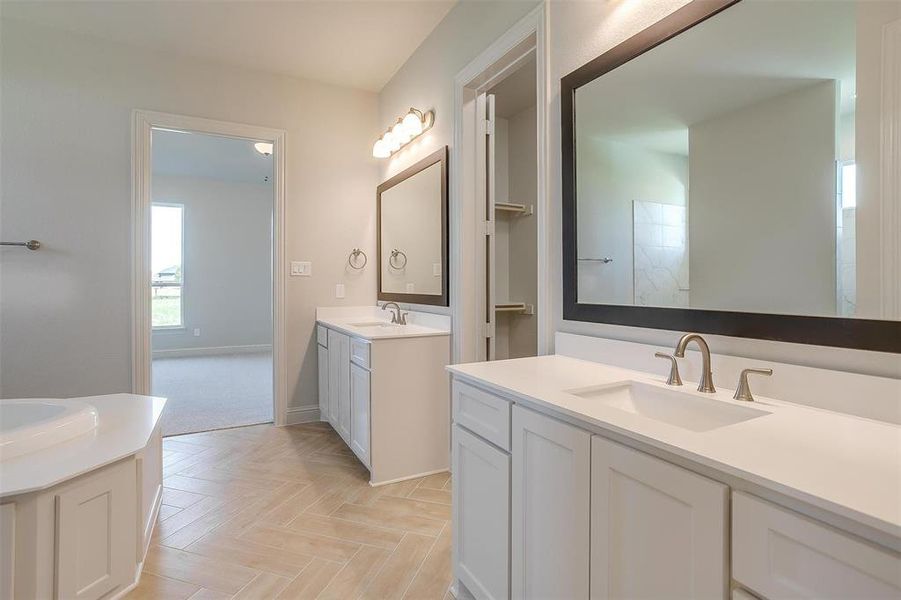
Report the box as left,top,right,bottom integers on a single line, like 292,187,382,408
732,492,901,600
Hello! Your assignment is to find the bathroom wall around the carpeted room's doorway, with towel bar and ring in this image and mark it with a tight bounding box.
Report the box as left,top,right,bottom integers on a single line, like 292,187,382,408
0,19,378,407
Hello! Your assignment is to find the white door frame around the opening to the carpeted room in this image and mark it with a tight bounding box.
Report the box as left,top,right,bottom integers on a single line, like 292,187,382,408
131,110,288,425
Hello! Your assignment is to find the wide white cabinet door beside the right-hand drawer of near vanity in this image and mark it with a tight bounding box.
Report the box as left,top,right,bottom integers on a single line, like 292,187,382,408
591,436,729,599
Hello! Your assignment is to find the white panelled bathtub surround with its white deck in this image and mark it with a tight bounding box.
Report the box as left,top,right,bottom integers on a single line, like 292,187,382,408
0,394,166,600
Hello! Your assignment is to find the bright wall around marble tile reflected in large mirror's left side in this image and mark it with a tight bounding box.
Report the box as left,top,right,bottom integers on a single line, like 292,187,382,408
576,138,688,305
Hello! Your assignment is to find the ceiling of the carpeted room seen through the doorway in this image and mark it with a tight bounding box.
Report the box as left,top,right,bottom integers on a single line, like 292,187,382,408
151,129,272,185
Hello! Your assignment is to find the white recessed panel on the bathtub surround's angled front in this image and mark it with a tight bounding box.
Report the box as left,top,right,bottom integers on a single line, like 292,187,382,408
55,460,138,600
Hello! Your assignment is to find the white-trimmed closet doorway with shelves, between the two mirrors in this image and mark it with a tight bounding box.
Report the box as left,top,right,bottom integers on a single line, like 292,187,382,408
451,5,553,363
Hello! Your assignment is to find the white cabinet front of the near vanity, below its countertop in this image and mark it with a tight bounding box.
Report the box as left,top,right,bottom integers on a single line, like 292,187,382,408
452,377,901,600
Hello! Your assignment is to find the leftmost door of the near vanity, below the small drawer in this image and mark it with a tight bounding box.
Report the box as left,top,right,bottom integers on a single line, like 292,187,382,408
452,425,510,600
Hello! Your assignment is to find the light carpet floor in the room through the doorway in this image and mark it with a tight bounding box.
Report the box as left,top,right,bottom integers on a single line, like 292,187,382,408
153,353,272,436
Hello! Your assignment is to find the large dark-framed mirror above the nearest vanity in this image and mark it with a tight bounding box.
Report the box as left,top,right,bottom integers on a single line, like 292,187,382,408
561,0,901,352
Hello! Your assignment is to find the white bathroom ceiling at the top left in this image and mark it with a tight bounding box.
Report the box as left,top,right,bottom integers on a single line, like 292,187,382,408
2,0,456,91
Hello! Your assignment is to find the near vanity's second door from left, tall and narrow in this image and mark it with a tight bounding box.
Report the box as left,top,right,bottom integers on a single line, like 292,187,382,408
512,406,591,600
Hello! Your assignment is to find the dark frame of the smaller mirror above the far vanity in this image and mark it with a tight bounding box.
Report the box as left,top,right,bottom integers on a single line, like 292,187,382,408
375,146,450,306
